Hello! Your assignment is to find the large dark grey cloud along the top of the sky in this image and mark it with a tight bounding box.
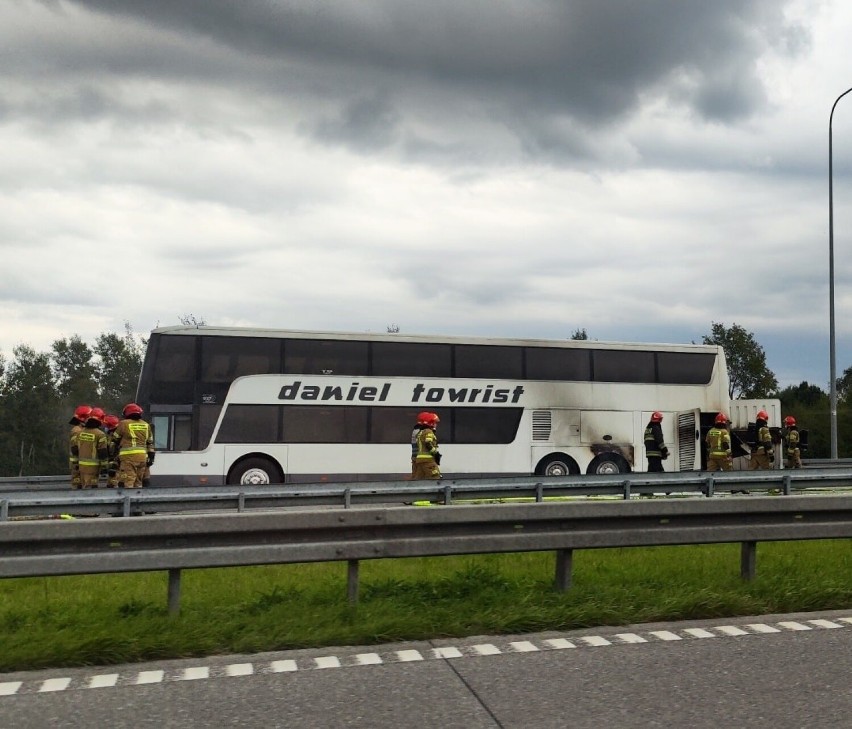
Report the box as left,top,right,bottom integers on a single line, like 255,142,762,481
18,0,807,164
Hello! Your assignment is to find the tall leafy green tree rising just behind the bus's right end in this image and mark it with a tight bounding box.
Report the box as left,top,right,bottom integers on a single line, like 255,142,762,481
703,322,778,399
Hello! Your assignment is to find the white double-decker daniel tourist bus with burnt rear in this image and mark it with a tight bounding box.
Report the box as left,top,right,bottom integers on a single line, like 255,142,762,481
137,326,780,485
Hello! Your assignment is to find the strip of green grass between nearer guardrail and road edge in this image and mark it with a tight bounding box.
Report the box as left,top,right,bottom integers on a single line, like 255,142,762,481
0,540,852,671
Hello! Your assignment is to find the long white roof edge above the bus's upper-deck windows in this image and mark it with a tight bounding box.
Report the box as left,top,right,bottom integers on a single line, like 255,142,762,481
151,325,722,354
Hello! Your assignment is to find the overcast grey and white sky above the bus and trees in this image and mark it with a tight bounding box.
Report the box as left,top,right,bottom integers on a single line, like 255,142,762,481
0,0,852,388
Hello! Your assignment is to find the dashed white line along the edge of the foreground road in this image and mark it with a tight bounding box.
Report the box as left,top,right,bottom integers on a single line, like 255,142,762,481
0,616,852,700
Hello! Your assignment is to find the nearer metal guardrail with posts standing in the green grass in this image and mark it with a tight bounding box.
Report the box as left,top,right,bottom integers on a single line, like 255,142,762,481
0,496,852,612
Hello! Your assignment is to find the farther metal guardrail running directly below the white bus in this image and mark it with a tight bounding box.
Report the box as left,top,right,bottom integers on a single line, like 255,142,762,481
0,467,852,522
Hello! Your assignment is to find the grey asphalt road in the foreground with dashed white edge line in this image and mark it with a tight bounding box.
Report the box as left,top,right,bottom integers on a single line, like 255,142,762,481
0,610,852,729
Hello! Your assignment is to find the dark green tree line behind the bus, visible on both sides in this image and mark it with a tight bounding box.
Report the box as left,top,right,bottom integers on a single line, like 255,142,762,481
0,316,852,476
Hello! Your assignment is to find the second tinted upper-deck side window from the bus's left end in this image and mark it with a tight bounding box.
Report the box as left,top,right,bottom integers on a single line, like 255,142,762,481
201,337,281,383
